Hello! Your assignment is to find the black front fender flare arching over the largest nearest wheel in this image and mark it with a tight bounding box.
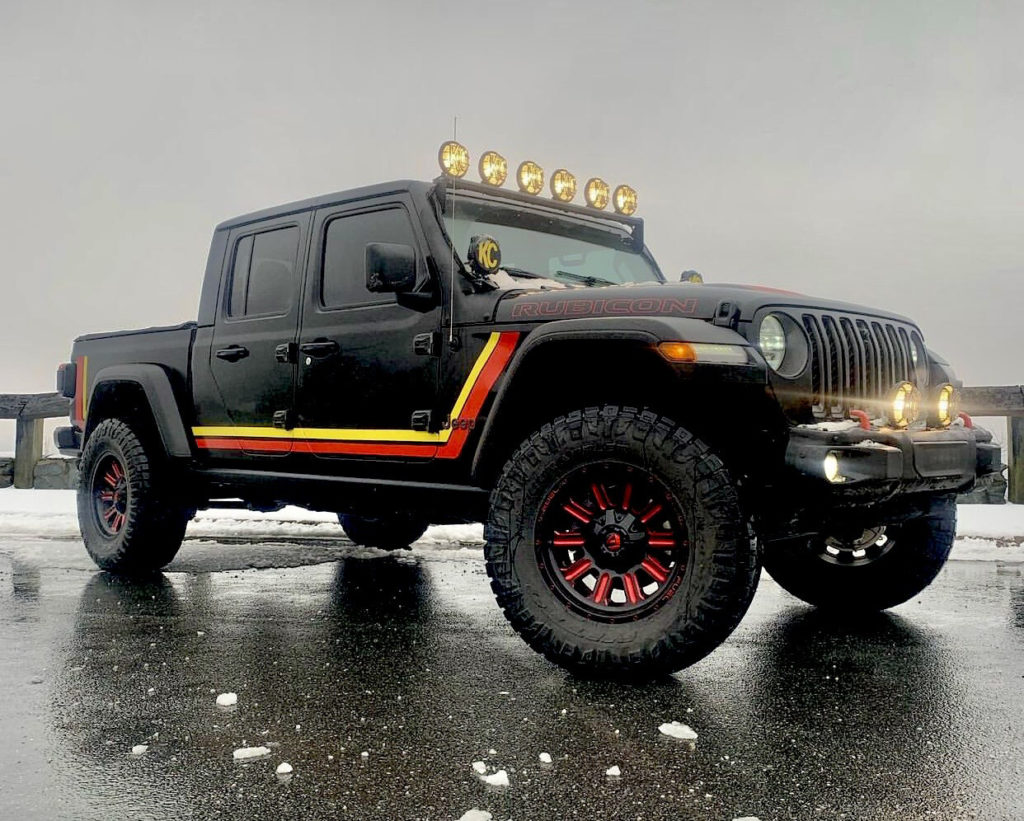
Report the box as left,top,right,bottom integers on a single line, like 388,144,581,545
470,316,766,478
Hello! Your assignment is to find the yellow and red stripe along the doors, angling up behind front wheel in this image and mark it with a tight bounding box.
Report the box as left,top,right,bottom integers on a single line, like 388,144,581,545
193,332,519,459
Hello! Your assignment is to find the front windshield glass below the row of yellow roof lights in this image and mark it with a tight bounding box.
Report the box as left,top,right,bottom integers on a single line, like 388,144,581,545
444,197,662,288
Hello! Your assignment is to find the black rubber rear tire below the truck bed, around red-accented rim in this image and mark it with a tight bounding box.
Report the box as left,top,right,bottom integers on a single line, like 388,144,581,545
78,419,193,574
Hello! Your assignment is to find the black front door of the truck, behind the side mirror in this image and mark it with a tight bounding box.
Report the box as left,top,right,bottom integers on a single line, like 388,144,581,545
296,197,440,461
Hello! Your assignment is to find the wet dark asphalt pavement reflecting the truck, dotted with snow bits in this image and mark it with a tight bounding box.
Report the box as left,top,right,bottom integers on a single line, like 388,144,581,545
0,537,1024,821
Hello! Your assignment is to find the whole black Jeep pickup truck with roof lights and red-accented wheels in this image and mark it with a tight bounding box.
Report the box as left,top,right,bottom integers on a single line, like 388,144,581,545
55,143,1001,676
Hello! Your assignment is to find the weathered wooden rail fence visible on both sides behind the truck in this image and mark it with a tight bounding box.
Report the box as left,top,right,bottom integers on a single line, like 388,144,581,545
0,385,1024,505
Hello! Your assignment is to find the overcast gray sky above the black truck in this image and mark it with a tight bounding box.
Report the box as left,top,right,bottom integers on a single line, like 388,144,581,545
0,0,1024,449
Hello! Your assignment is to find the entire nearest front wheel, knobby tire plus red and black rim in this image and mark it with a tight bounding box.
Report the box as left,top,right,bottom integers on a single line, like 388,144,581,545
485,406,761,677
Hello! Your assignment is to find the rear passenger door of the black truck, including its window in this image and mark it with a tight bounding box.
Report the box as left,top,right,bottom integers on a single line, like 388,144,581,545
197,214,311,456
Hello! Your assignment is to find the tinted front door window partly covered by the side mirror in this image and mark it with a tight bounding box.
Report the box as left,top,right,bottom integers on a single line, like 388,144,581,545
321,208,416,308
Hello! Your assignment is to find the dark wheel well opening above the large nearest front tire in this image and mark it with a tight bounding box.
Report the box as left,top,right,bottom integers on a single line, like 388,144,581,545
474,340,786,487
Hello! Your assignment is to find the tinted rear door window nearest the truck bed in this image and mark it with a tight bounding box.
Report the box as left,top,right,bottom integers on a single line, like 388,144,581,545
227,225,299,316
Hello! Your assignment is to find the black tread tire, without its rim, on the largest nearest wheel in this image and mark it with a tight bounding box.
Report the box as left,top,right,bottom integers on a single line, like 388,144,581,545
484,405,761,679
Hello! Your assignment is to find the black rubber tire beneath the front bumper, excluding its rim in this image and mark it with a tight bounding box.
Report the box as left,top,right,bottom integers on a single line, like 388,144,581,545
764,495,956,612
